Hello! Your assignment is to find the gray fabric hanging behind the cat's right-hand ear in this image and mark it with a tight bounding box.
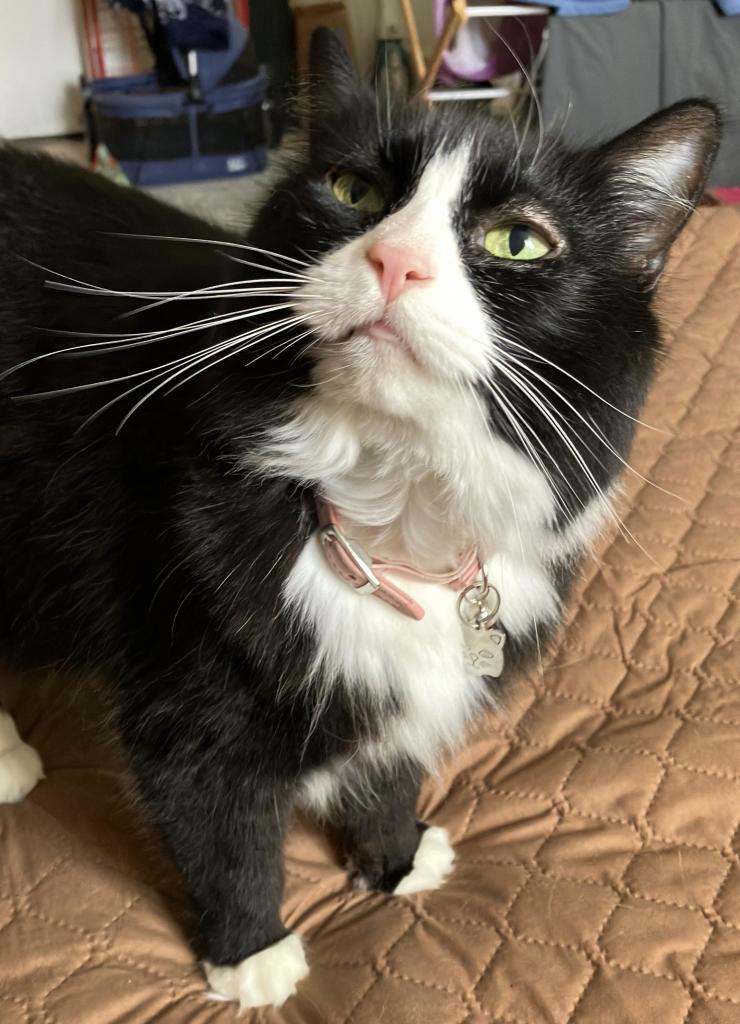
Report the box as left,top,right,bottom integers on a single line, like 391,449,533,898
540,0,740,186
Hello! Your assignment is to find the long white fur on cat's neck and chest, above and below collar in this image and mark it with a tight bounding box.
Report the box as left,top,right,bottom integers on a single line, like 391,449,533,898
271,400,604,809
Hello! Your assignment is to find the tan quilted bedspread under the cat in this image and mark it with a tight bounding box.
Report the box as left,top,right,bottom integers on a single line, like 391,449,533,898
0,203,740,1024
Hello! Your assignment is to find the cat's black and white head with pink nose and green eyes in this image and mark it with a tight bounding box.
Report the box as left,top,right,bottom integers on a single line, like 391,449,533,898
248,32,720,516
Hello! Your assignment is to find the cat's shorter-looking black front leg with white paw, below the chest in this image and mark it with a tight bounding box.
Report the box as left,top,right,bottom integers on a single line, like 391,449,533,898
336,765,454,896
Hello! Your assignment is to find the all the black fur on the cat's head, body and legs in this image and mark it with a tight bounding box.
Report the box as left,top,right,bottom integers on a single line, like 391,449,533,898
0,29,717,964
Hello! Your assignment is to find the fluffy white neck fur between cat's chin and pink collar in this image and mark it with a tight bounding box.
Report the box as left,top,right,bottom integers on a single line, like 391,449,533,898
255,393,553,572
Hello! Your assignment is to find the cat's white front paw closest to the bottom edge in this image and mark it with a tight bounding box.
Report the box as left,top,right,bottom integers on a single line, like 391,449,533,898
204,932,308,1010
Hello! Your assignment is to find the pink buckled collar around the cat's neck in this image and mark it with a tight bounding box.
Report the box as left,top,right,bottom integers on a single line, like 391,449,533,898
316,496,481,620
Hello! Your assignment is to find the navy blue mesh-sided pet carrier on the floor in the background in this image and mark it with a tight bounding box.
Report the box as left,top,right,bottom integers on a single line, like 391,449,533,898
83,0,267,185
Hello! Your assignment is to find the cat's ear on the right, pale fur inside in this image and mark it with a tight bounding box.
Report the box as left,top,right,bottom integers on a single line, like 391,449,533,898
596,99,721,290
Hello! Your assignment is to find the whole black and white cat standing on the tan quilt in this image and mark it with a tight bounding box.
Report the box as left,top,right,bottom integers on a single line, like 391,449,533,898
0,33,719,1007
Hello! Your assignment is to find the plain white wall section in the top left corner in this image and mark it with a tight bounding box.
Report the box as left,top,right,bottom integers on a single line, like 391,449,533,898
0,0,82,138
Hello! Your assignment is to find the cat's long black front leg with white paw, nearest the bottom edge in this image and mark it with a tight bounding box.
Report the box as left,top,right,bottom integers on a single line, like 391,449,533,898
117,674,308,1009
